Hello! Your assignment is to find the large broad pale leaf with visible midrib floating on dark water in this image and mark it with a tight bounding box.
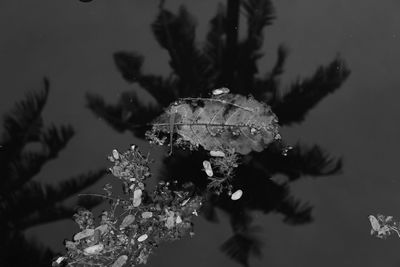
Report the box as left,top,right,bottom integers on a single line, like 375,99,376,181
146,94,278,155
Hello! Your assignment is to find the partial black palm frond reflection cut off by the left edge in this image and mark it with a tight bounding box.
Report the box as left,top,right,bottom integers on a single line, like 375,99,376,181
0,79,105,267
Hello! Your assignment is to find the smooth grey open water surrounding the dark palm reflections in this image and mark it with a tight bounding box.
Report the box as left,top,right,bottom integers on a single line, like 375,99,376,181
0,0,400,266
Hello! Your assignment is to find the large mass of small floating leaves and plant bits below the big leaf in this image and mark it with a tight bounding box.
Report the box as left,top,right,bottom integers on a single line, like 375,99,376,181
53,146,202,267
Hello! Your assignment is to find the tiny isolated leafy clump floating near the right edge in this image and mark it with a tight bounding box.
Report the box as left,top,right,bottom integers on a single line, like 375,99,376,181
368,214,400,239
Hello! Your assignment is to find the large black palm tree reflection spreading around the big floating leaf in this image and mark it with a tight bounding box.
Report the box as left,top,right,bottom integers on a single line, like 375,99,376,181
87,0,350,266
